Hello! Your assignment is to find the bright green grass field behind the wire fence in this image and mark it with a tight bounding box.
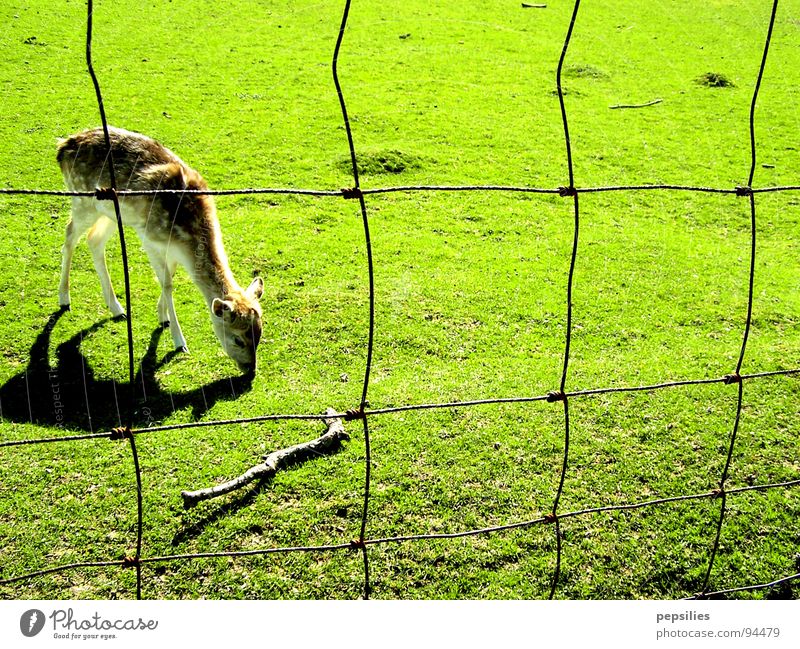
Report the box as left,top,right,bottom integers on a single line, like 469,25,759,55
0,0,800,599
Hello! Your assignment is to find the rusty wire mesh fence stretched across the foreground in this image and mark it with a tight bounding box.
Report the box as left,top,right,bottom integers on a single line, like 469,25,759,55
0,0,800,599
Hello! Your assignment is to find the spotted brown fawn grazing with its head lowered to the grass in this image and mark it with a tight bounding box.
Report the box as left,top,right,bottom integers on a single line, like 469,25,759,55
57,128,264,373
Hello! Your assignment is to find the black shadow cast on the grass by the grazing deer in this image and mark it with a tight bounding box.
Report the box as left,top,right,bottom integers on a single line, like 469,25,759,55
0,309,253,432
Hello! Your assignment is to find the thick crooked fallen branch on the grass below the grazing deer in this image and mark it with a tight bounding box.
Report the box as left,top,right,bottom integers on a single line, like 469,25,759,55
181,408,350,509
